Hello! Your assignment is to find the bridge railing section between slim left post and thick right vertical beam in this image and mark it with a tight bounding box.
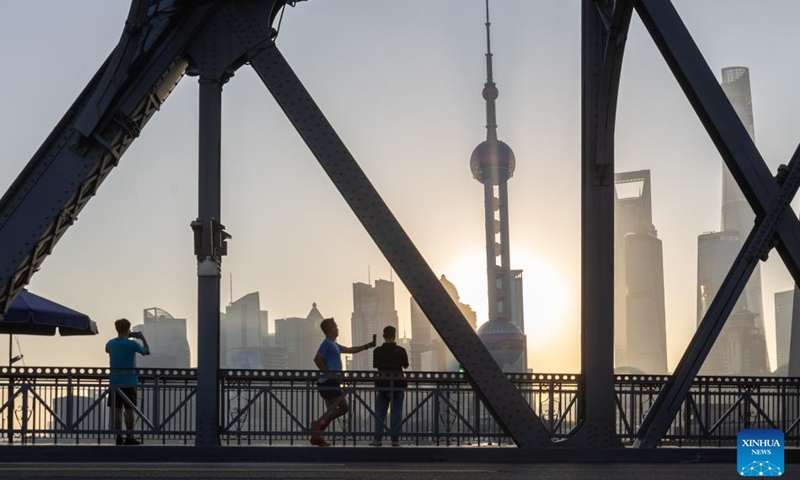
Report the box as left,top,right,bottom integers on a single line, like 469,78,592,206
222,370,579,445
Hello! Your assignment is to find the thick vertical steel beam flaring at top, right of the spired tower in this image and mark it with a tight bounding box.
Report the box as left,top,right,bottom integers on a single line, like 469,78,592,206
571,0,633,448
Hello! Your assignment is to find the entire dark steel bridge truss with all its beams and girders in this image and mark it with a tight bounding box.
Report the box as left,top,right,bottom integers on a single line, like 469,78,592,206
0,0,800,447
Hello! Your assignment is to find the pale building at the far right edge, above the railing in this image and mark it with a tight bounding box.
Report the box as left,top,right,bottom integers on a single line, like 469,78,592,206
775,287,800,377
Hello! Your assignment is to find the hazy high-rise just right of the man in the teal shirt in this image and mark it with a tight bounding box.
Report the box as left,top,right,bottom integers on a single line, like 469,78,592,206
132,307,191,368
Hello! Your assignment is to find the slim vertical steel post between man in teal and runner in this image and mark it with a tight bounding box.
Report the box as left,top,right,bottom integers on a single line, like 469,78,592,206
195,76,222,447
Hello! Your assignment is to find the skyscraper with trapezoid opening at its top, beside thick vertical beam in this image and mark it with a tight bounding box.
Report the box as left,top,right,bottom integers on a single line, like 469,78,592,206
614,170,667,374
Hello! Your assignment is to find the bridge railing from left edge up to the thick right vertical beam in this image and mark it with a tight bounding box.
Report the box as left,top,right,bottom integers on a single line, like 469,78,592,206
0,367,580,445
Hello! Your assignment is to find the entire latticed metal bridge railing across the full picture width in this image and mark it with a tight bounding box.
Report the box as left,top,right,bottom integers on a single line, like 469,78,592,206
0,367,800,446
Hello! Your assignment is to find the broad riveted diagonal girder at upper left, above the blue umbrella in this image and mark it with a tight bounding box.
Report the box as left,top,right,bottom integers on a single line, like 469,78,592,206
0,0,217,312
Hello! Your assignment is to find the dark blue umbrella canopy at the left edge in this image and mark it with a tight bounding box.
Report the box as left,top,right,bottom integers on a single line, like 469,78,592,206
0,290,98,337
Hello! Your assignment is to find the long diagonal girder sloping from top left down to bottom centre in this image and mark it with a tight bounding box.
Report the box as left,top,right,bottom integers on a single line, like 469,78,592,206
216,2,551,448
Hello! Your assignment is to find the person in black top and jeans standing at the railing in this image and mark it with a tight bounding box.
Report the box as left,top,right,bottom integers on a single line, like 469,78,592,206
370,326,408,447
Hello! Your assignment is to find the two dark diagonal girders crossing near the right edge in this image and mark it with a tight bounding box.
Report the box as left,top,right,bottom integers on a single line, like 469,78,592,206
635,0,800,448
